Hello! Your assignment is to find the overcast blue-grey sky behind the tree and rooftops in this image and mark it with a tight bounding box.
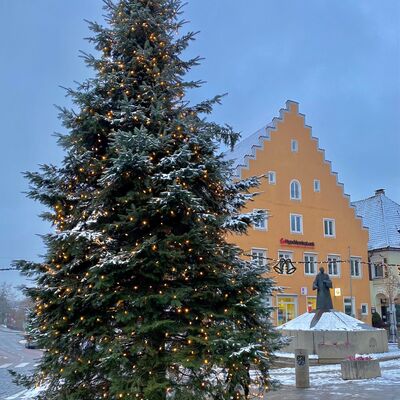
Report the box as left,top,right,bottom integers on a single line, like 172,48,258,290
0,0,400,284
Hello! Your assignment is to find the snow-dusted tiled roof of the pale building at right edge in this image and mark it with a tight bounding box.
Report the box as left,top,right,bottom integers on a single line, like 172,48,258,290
352,189,400,250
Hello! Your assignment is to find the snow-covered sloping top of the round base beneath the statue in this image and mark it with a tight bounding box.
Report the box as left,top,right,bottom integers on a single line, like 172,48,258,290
276,311,378,332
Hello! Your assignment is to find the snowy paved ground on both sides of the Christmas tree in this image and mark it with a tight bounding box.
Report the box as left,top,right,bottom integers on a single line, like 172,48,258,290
0,327,400,400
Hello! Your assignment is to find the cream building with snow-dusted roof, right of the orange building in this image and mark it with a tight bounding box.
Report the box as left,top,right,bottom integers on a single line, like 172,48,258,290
353,189,400,324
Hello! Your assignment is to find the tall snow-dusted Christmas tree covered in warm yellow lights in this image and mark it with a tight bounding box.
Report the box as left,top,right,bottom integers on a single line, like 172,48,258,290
17,0,279,400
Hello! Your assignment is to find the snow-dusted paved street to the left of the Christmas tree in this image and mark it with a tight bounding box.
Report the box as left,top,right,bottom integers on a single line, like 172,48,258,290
0,327,41,400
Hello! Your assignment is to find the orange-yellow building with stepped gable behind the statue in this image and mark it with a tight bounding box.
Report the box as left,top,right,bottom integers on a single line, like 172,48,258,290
232,101,371,325
